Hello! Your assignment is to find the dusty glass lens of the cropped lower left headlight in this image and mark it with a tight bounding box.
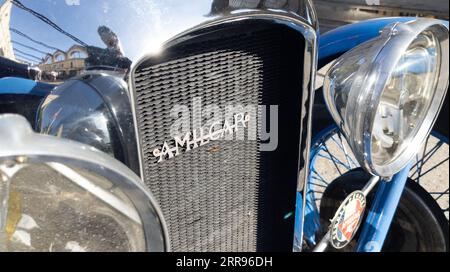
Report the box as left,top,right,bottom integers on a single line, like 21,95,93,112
0,165,146,252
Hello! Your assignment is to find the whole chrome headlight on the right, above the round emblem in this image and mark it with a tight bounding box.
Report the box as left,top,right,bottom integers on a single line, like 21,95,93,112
324,19,449,177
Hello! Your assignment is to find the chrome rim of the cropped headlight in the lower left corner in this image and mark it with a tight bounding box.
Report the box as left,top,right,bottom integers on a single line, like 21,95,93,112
0,114,170,251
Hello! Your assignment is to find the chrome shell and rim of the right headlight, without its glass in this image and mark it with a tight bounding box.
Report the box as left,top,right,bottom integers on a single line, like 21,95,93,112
324,19,448,177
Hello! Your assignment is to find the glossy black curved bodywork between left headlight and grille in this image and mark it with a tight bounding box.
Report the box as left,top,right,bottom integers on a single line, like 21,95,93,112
36,74,139,174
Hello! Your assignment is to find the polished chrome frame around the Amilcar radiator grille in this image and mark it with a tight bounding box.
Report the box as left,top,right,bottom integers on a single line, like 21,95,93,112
129,10,318,249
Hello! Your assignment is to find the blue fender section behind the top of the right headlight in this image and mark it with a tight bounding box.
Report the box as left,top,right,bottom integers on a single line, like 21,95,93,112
319,17,415,68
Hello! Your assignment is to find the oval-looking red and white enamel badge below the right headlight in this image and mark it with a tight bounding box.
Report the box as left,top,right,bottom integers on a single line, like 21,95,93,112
331,191,366,249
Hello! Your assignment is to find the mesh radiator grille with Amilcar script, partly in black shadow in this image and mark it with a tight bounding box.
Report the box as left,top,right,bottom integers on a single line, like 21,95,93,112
133,21,305,251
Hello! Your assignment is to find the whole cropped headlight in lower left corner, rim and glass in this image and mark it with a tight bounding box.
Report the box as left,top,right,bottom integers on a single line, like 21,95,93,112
0,114,169,252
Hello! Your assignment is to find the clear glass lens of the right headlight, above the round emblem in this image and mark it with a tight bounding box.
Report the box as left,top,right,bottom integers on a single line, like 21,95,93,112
371,31,440,165
